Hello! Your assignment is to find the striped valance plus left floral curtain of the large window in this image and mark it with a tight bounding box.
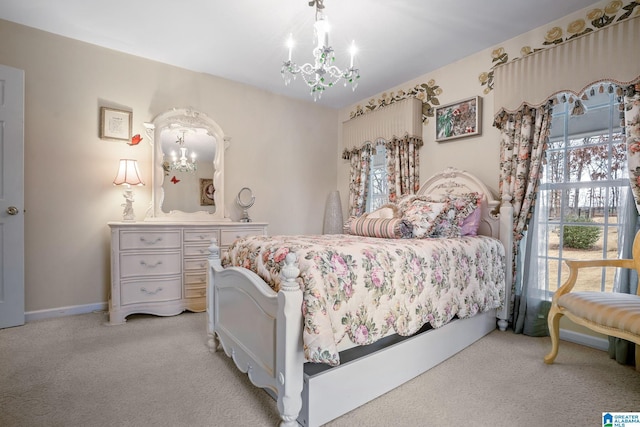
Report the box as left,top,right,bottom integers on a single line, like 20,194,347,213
493,16,640,330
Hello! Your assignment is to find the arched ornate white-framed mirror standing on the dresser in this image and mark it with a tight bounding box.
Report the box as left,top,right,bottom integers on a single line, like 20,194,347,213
145,108,226,221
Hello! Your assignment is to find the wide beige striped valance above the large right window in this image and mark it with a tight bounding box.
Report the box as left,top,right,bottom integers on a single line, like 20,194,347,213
493,17,640,114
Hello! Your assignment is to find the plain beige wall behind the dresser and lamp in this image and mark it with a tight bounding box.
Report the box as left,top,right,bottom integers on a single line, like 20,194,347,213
0,20,338,312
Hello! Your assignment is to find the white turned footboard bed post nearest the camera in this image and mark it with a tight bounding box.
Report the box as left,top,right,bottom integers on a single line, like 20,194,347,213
276,253,305,427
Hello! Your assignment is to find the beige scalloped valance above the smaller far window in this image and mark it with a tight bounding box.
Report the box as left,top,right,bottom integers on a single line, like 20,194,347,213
342,98,422,157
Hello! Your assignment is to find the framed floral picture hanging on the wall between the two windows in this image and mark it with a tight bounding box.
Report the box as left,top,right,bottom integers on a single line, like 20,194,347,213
435,96,482,142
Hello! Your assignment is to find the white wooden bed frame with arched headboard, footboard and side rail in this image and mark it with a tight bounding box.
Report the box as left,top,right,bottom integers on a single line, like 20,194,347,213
207,168,513,426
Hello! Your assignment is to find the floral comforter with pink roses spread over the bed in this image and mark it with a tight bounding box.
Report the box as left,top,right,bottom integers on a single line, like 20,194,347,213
222,235,505,366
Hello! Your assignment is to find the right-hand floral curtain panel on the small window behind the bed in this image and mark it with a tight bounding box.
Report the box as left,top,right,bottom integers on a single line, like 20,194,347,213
385,136,422,203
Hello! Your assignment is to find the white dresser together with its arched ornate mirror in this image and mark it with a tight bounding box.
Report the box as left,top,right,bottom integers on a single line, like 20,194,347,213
109,108,267,325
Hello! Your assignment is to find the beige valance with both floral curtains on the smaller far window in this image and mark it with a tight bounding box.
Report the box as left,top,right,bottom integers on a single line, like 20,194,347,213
342,98,423,216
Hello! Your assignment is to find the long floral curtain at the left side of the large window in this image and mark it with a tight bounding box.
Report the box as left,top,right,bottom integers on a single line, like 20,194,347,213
494,101,552,324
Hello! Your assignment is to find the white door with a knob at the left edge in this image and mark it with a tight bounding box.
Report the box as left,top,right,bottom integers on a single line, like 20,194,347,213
0,65,24,329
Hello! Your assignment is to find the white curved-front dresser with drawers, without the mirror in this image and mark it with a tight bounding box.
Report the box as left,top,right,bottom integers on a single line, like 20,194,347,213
109,221,267,325
